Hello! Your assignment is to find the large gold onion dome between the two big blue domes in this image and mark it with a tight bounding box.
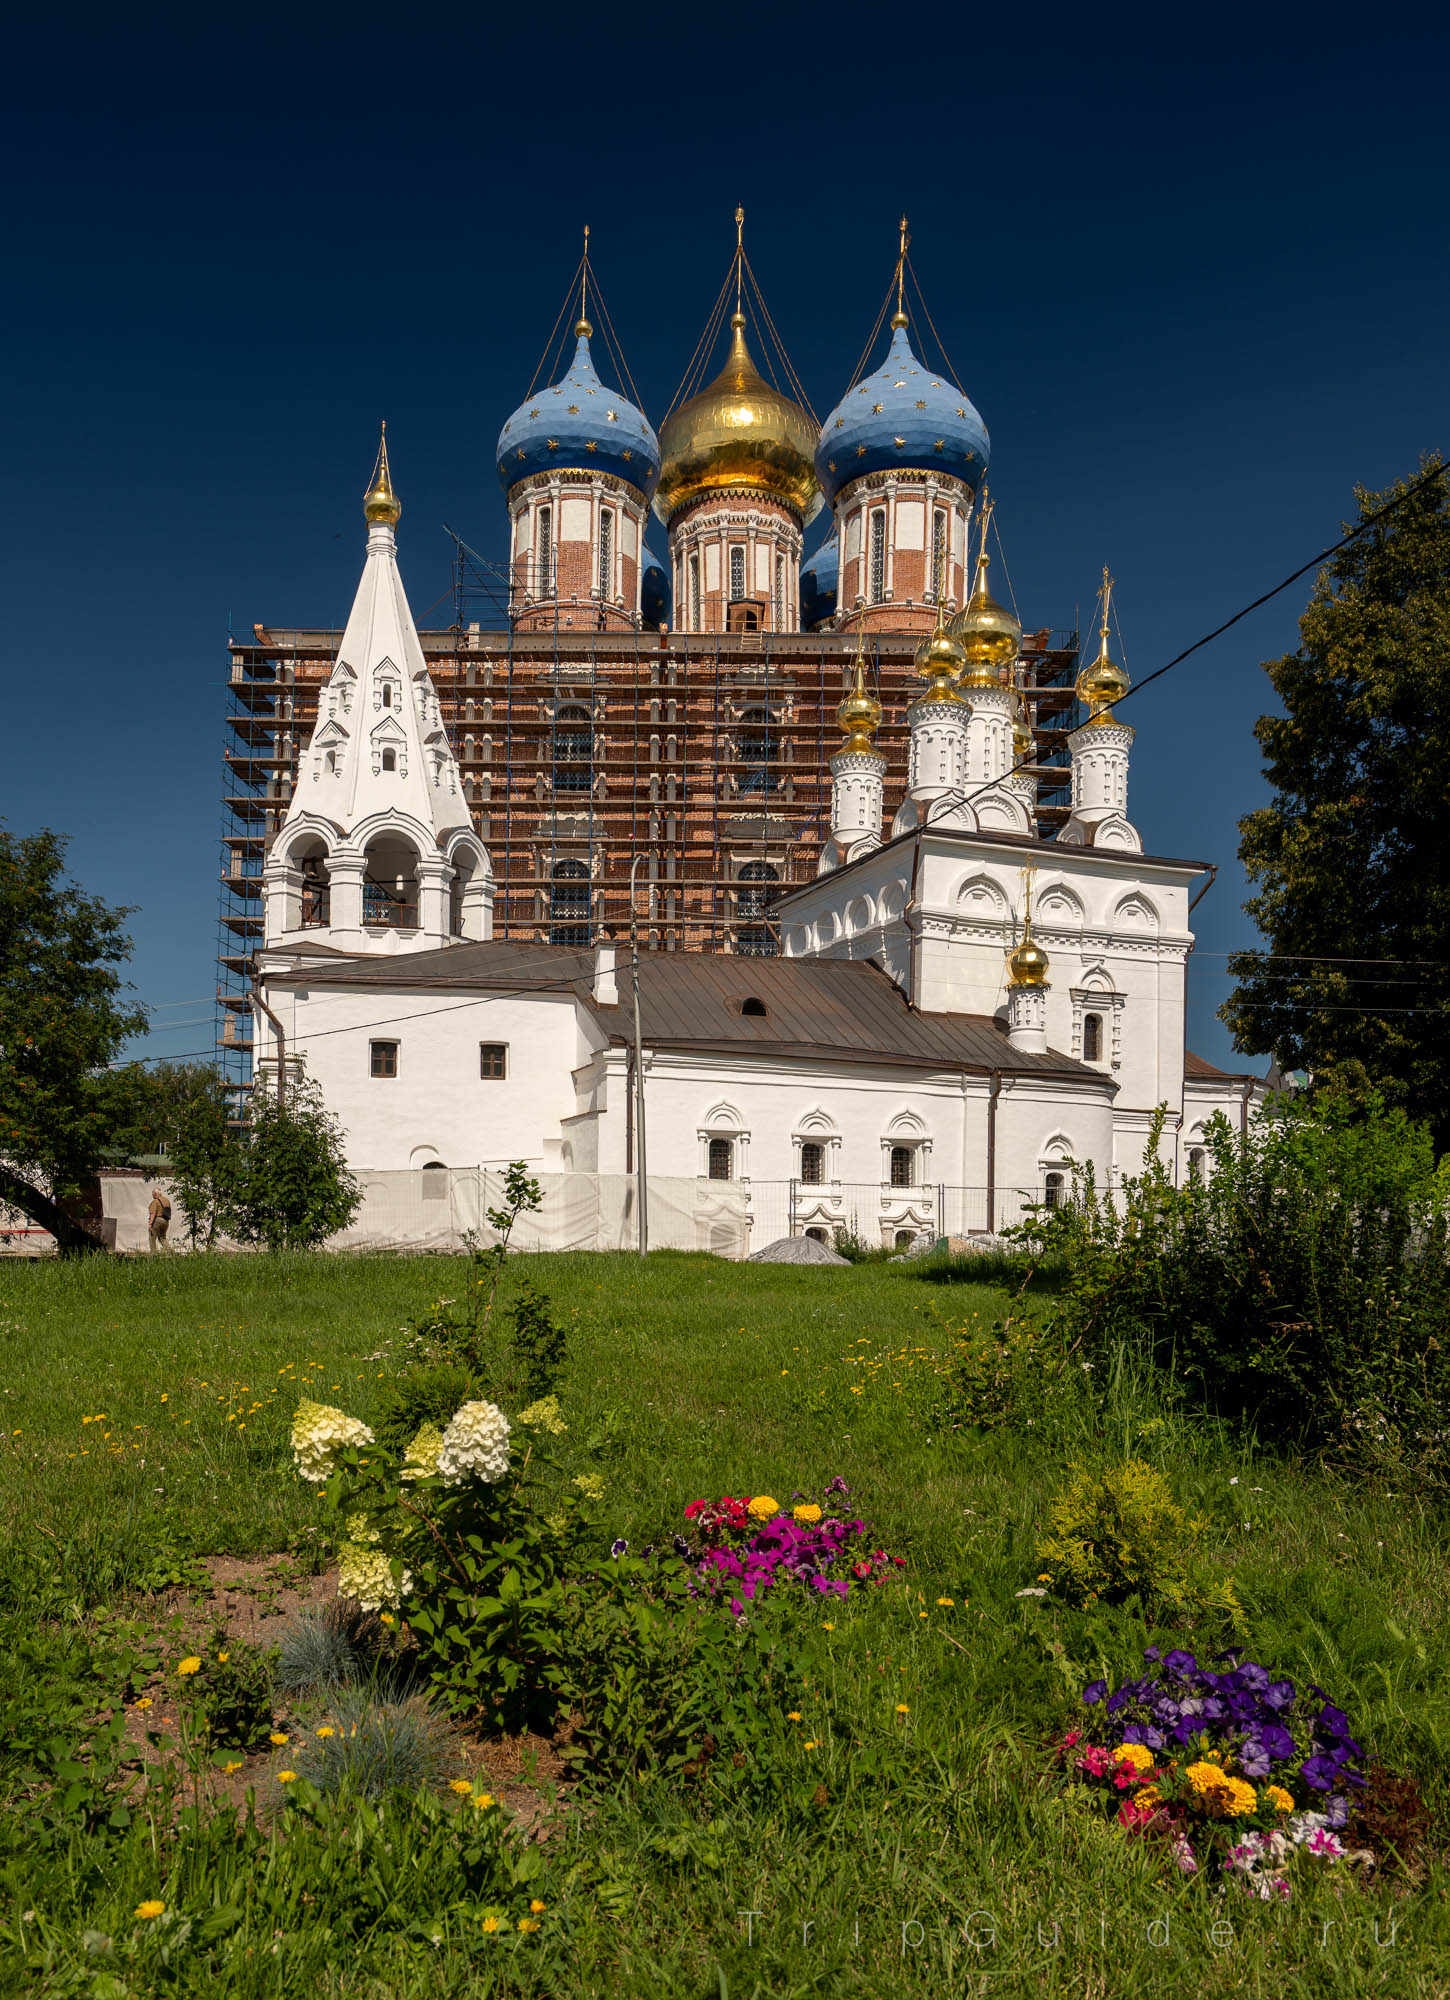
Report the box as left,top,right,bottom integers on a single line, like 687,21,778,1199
654,312,820,524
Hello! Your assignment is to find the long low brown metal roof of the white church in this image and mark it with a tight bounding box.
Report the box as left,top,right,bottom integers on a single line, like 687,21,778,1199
268,938,1102,1082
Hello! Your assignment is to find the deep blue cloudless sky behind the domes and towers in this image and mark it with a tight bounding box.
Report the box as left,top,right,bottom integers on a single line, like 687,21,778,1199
0,6,1450,1066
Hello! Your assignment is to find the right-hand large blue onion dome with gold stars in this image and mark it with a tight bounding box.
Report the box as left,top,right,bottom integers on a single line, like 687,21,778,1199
816,312,992,506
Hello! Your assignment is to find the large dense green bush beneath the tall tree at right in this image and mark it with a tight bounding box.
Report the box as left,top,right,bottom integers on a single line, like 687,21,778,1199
1034,1098,1450,1478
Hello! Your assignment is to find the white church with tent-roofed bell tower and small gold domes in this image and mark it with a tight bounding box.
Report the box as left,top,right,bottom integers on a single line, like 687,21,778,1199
256,448,1262,1254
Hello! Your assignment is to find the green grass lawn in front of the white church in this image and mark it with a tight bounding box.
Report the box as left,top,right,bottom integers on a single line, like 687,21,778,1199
0,1252,1450,2000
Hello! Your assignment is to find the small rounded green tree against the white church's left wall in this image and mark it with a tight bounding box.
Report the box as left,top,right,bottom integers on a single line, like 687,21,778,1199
228,1076,362,1250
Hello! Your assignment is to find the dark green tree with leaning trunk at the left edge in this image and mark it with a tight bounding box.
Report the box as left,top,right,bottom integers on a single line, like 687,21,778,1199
0,828,146,1254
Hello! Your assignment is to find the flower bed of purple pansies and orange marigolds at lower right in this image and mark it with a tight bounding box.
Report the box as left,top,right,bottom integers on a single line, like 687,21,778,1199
1058,1646,1368,1902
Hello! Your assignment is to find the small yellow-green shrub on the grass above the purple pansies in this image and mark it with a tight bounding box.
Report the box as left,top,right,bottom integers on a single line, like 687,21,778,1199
1038,1458,1242,1624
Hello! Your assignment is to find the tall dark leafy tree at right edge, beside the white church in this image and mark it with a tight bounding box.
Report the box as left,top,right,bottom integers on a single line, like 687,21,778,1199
1220,458,1450,1148
